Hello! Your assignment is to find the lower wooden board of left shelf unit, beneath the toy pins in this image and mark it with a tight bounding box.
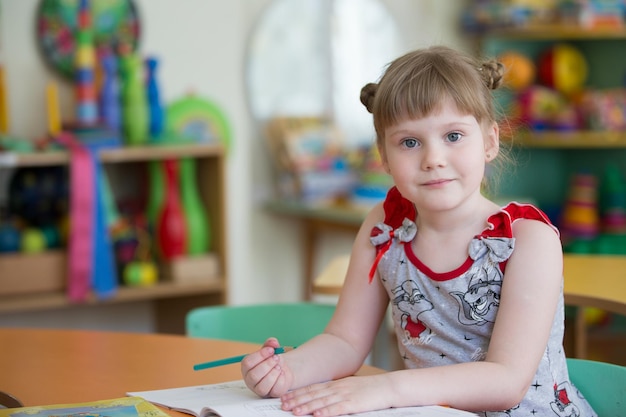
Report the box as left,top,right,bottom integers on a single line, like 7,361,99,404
0,278,225,313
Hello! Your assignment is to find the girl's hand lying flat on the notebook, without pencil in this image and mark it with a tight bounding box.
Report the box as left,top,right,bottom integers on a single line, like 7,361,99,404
281,374,391,417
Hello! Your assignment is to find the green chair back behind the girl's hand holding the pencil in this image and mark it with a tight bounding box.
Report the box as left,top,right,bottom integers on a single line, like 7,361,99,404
185,302,335,346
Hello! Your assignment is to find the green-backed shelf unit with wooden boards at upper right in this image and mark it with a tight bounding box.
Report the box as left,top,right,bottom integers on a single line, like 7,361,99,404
477,24,626,215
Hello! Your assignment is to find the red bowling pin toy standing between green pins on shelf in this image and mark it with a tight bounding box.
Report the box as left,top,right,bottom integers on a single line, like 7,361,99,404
157,159,187,260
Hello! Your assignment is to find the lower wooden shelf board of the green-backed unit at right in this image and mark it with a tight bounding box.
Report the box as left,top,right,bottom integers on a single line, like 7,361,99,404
508,131,626,149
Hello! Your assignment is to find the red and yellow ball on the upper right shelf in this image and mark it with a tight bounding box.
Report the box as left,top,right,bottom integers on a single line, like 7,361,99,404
537,43,588,96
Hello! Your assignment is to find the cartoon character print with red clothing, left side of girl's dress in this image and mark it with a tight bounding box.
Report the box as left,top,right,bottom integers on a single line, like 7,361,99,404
393,281,433,343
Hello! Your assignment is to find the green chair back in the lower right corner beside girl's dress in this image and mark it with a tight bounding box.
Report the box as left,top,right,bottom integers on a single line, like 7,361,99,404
567,358,626,417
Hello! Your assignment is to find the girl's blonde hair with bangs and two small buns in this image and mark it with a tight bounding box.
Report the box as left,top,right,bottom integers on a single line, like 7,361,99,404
361,46,509,190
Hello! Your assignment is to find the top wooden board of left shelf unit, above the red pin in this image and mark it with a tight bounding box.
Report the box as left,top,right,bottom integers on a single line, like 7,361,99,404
0,144,224,168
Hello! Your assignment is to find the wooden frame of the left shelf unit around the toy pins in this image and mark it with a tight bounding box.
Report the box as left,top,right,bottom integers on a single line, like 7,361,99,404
0,144,228,333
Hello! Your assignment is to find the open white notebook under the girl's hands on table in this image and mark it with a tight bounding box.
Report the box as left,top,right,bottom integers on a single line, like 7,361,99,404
127,380,476,417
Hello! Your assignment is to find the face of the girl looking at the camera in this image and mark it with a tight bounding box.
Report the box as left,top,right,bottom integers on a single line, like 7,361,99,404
381,99,498,211
